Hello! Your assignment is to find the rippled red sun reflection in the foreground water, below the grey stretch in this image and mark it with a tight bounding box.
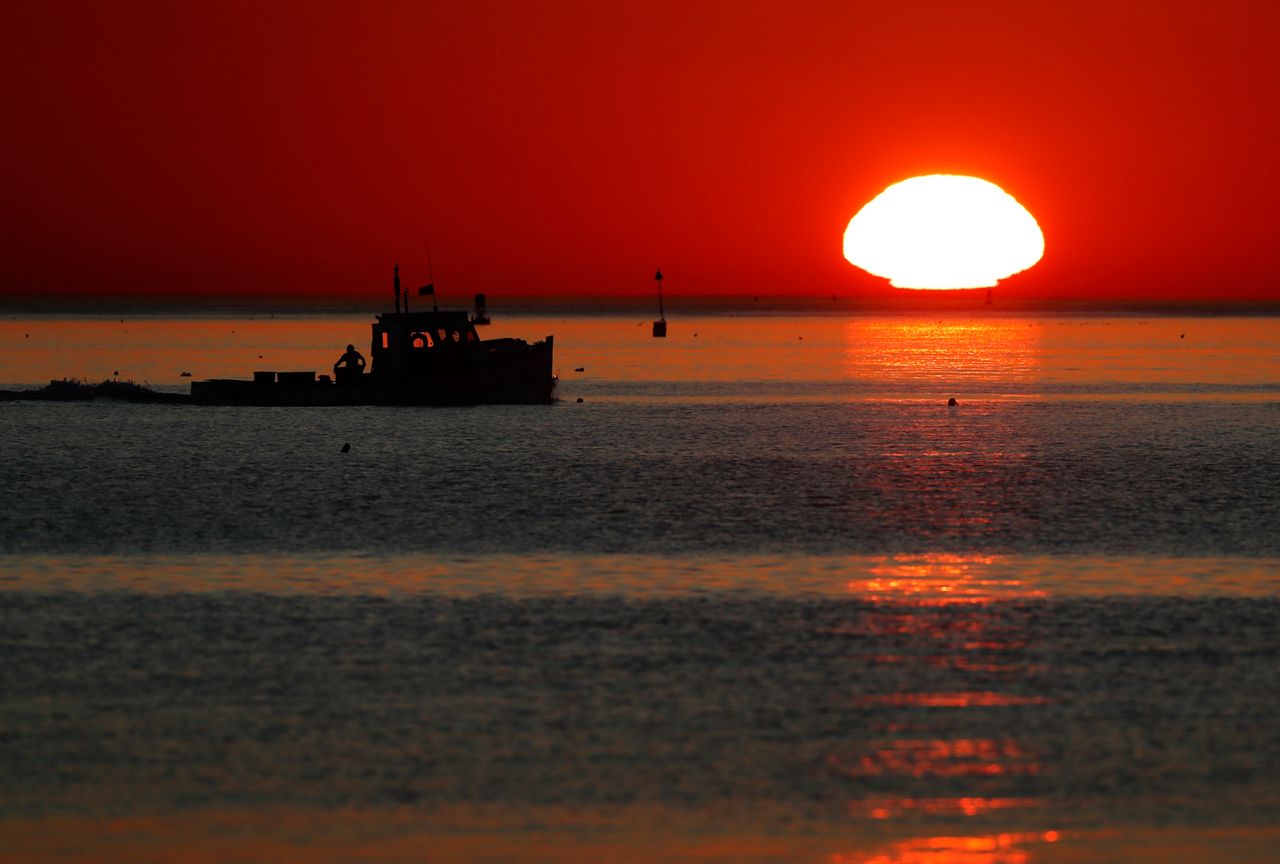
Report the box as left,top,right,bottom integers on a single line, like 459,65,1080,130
828,554,1050,844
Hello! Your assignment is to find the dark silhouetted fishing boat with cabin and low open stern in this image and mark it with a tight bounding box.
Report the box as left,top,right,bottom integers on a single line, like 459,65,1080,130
191,266,556,406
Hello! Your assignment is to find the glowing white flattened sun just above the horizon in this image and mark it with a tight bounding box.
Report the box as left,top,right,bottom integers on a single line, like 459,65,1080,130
845,174,1044,288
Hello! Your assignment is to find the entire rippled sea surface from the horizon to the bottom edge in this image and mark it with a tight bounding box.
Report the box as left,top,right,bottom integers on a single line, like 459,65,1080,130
0,311,1280,864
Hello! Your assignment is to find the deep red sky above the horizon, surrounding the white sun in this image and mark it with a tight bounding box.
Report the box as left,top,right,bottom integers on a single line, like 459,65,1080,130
0,0,1280,300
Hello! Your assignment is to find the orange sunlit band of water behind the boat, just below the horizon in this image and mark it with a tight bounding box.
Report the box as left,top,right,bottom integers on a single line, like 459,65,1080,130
0,311,1280,401
